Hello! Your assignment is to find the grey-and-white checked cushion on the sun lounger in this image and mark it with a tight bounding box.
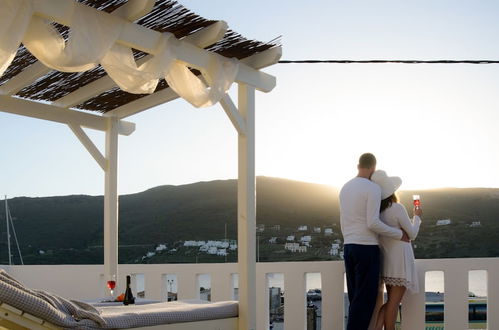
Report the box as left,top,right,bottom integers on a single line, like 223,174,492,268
0,270,238,329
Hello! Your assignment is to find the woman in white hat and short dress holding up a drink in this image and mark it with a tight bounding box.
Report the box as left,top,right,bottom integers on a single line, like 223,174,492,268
371,170,423,330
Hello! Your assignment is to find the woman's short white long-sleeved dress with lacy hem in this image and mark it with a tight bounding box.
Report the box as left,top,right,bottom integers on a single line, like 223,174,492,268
380,203,421,293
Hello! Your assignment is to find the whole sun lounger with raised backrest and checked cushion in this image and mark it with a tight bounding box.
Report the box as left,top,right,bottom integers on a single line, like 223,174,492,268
0,270,238,330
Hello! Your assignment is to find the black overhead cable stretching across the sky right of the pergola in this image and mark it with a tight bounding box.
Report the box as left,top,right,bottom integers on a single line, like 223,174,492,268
278,60,499,64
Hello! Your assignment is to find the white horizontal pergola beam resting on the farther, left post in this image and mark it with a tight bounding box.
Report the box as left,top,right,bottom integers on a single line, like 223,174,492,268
0,95,135,135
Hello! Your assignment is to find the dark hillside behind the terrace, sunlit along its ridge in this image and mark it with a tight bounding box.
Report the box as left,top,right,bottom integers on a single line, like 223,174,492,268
0,177,499,264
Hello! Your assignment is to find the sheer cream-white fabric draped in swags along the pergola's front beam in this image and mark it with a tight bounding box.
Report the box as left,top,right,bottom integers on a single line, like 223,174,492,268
0,0,238,107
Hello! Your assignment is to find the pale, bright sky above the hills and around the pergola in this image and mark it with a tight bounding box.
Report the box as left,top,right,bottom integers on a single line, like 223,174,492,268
0,0,499,197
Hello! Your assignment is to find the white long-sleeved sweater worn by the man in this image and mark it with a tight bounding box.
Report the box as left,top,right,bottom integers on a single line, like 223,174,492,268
340,177,402,245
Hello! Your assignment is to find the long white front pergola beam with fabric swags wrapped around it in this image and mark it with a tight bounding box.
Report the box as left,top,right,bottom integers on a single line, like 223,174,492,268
34,0,276,92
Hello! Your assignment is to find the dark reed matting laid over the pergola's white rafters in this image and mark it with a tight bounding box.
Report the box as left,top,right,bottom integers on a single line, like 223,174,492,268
0,0,279,113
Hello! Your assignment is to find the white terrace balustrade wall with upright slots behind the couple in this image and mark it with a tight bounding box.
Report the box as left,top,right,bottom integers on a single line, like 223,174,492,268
0,258,499,330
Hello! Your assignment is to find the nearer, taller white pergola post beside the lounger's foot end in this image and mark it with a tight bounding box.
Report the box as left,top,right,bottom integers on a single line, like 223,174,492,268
237,84,256,330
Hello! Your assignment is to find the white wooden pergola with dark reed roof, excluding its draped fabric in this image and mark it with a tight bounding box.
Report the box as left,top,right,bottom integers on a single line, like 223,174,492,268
0,0,282,330
